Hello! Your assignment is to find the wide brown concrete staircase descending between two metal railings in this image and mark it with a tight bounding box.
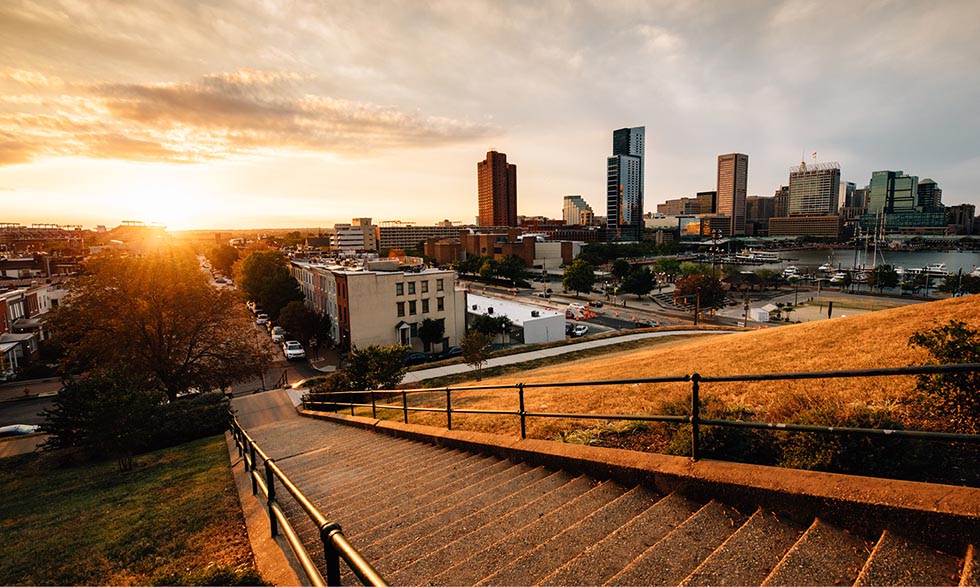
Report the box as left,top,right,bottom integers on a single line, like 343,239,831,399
236,400,980,585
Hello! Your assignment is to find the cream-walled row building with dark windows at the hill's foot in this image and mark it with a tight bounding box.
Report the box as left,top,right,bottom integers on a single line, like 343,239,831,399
290,260,466,351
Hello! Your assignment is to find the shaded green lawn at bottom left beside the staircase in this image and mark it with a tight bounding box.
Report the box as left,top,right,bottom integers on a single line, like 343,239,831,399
0,436,261,585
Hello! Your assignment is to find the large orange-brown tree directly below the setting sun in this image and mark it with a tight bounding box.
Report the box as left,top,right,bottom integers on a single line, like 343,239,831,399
48,250,271,401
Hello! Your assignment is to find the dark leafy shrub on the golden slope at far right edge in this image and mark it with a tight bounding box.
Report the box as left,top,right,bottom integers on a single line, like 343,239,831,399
909,320,980,434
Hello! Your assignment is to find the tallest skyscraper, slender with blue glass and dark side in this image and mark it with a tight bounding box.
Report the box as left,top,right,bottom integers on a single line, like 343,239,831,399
606,126,646,241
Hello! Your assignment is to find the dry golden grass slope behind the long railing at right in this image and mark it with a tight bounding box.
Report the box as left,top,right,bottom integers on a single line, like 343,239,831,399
400,296,980,438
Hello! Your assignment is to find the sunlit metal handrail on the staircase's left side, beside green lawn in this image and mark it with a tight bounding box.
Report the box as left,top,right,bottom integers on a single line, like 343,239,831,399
230,414,388,587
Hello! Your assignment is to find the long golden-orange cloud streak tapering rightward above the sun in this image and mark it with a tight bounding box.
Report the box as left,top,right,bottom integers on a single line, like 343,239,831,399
0,69,492,164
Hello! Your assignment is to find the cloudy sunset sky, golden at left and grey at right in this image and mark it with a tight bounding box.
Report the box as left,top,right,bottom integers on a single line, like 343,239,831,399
0,0,980,229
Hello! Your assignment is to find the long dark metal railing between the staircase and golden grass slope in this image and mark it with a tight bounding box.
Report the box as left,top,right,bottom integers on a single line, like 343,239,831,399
303,363,980,460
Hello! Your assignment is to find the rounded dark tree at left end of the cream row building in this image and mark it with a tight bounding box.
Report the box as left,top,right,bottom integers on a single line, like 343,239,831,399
236,251,303,320
